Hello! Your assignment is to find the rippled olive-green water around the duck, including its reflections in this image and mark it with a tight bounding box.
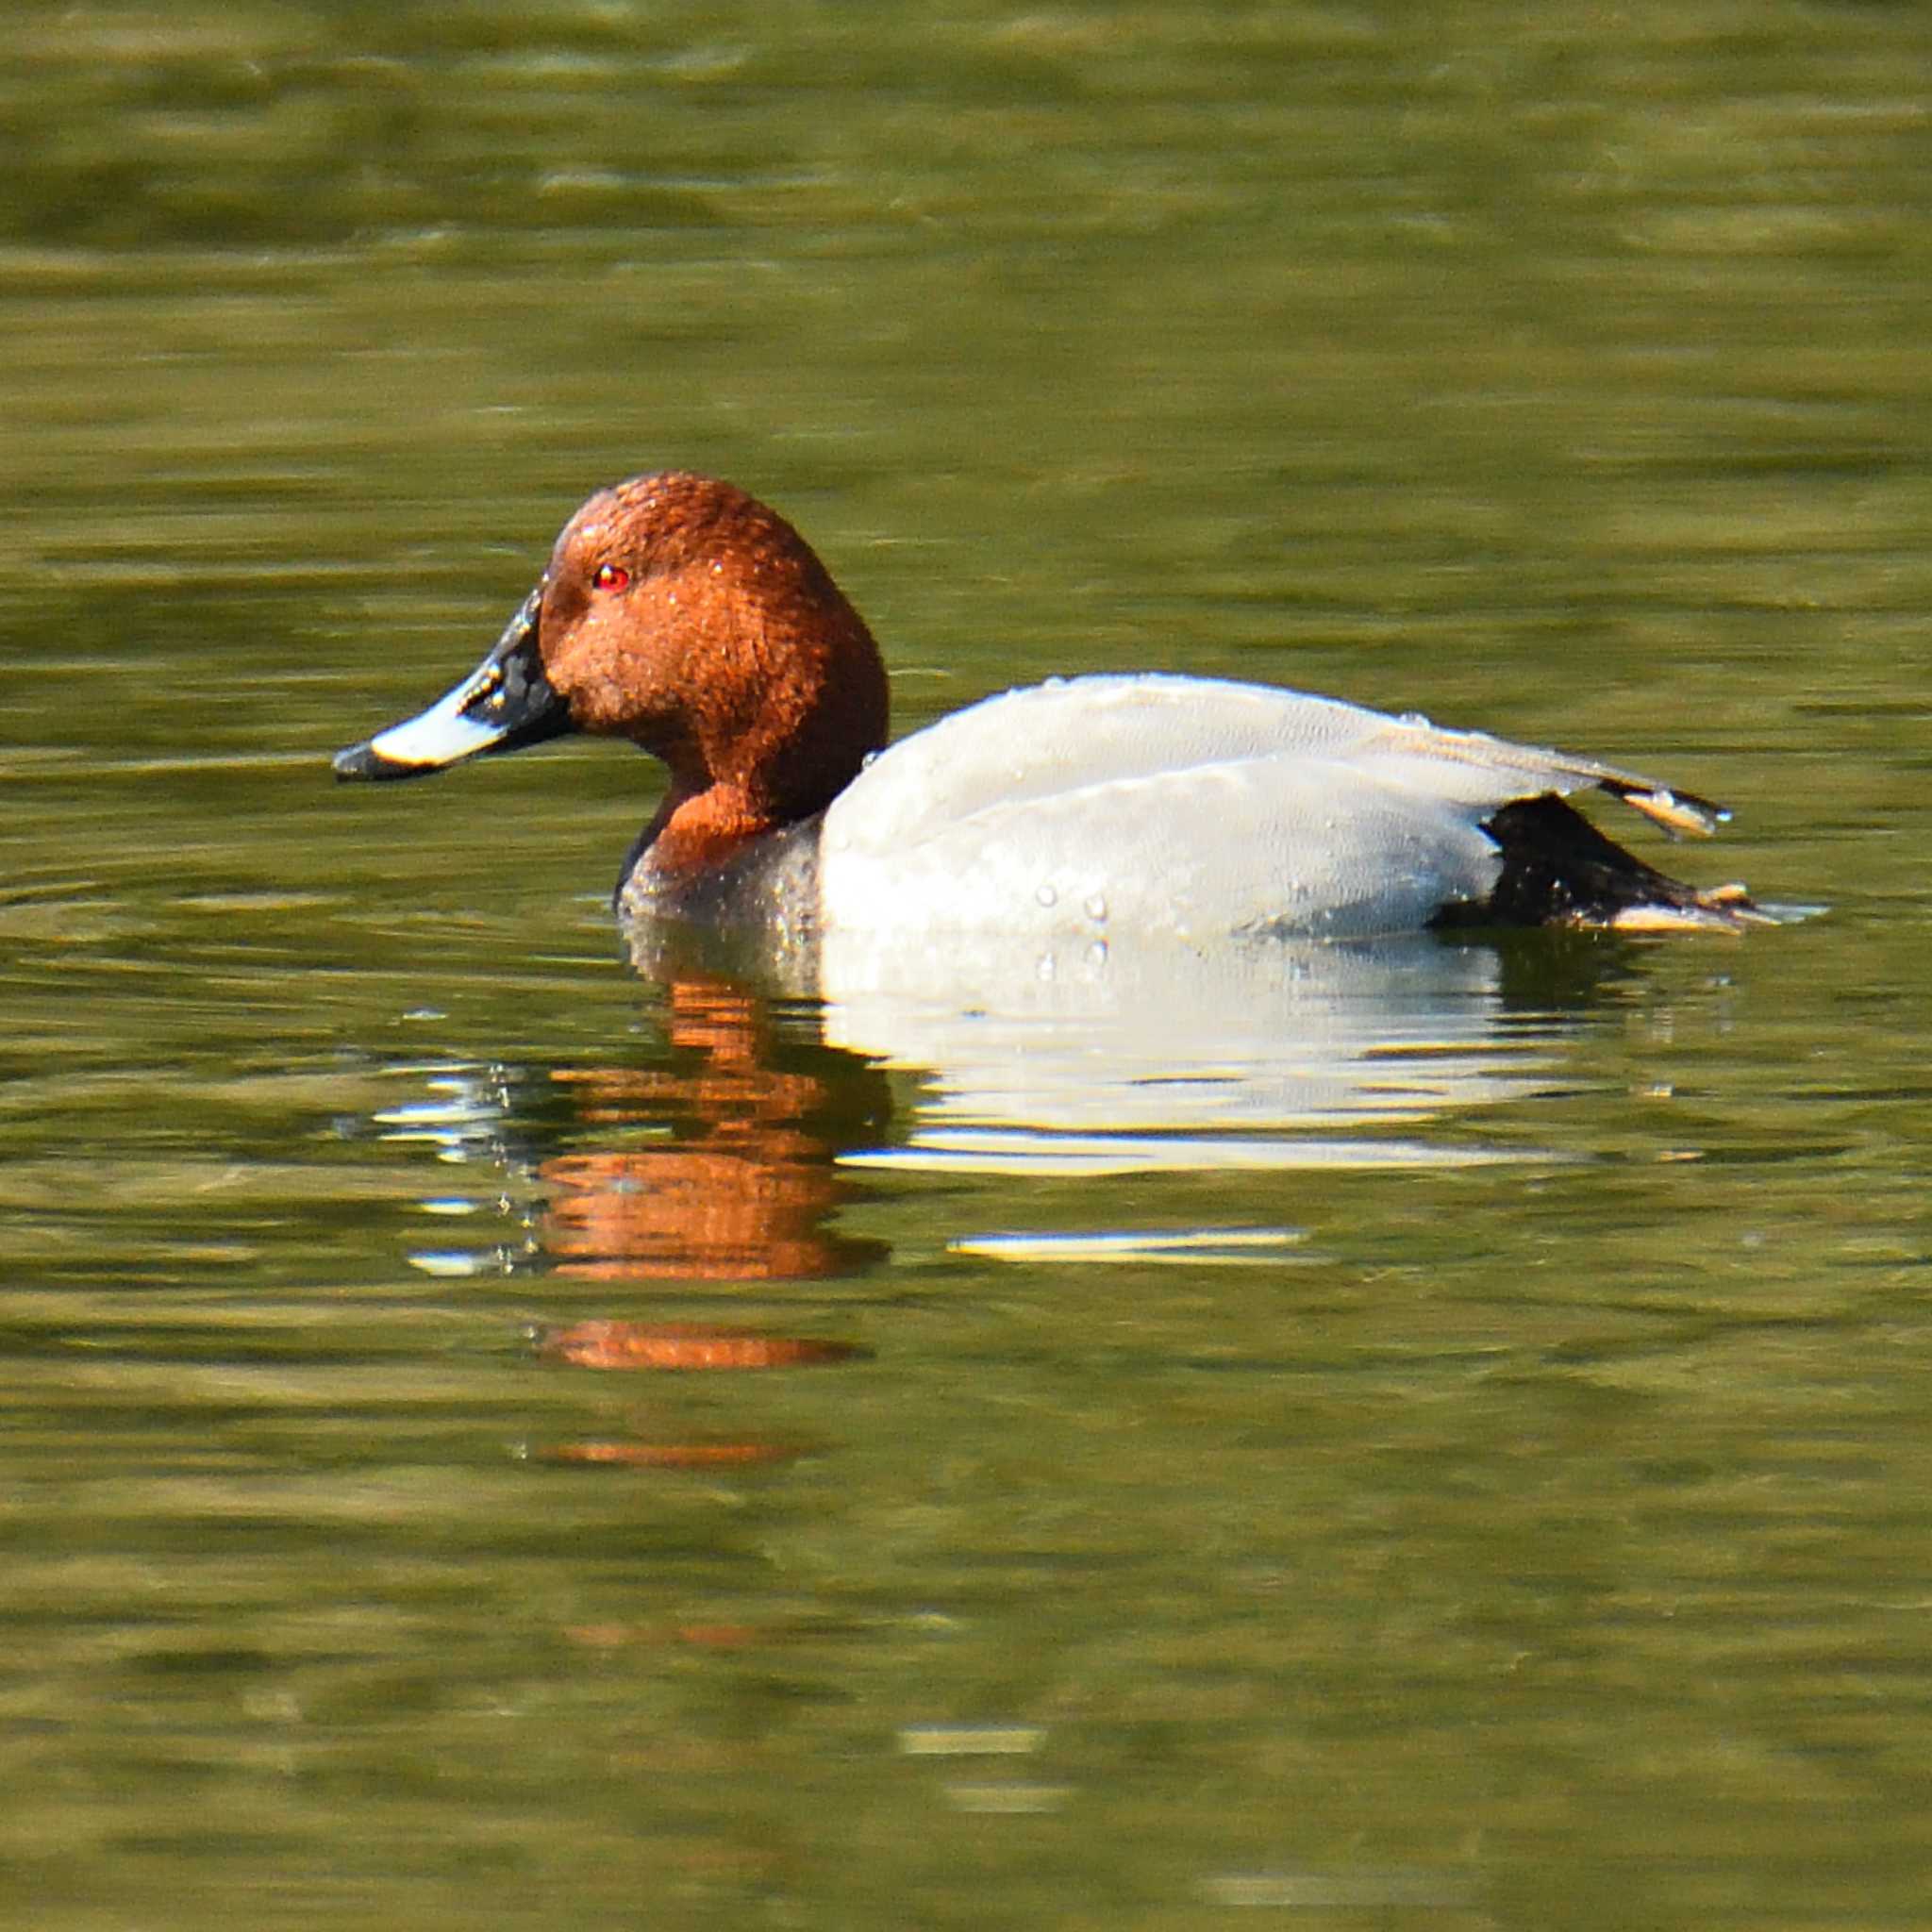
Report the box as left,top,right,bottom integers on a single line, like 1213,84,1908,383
0,4,1932,1932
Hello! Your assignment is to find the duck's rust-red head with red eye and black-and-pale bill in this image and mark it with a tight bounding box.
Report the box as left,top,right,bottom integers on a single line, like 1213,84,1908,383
334,472,887,863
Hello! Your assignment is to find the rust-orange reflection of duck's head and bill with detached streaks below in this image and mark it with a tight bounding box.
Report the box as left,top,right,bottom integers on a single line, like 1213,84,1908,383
378,975,887,1471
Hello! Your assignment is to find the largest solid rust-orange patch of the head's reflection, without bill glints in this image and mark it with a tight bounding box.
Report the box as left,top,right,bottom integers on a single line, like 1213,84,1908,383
539,979,881,1281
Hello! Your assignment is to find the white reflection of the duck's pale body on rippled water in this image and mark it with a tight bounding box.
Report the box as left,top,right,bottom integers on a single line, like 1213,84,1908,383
819,935,1547,1174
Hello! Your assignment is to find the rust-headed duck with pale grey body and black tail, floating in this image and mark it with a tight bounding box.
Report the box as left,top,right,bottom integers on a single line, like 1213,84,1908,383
334,470,1768,944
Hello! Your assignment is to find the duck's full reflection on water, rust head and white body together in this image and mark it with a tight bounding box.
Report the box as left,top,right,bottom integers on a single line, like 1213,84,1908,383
387,933,1631,1291
